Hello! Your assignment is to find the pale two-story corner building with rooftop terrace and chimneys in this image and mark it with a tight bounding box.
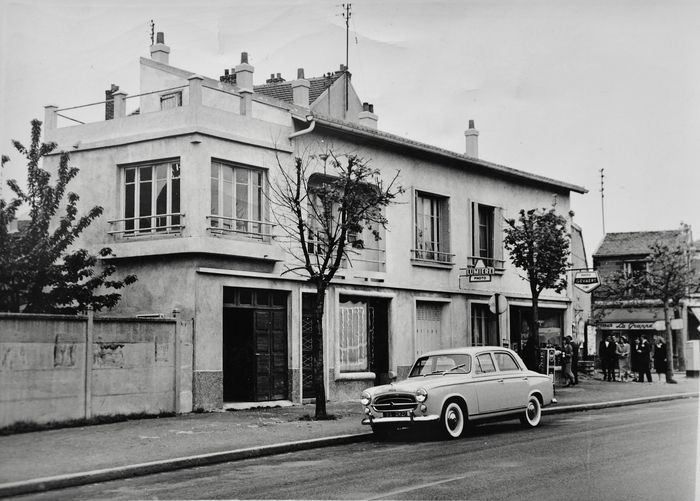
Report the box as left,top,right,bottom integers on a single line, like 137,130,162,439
45,34,586,409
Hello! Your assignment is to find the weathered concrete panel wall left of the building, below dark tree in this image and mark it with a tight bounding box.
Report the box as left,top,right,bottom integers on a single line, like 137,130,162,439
0,314,192,428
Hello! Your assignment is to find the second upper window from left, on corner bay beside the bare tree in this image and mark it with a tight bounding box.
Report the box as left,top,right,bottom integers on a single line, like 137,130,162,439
209,162,271,238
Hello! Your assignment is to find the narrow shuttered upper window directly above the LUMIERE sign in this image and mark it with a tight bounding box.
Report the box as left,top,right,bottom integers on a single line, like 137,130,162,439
471,202,503,268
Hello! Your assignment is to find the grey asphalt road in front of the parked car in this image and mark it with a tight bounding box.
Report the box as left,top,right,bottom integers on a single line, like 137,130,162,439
15,399,700,501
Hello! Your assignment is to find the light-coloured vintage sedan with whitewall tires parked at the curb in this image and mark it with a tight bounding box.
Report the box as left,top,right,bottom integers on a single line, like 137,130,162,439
360,346,554,438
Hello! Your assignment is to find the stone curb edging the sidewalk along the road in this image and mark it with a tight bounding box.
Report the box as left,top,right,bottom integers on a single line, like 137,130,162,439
0,393,698,498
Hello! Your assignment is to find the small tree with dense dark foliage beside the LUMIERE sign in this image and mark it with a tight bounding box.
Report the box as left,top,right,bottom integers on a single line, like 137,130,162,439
503,207,569,369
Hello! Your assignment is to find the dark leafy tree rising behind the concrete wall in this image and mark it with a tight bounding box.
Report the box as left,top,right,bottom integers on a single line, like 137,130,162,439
0,120,136,314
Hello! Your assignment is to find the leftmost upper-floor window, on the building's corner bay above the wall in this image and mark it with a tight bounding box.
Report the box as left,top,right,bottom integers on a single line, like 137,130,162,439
124,161,181,234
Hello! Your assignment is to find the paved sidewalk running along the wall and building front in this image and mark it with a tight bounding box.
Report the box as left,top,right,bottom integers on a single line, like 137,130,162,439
0,375,698,496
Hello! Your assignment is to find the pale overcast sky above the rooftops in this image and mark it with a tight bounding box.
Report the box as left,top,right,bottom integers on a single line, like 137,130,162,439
0,0,700,258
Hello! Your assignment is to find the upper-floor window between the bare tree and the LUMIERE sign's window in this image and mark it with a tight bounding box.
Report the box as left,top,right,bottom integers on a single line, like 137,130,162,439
413,192,453,263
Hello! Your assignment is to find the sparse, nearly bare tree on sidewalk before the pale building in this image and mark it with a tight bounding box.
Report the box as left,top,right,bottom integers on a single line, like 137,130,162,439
270,151,403,419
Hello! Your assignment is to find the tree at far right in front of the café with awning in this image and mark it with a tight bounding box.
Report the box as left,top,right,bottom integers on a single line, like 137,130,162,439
593,235,700,383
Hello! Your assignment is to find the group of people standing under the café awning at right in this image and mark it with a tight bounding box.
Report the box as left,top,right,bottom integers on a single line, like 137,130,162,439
598,334,668,383
